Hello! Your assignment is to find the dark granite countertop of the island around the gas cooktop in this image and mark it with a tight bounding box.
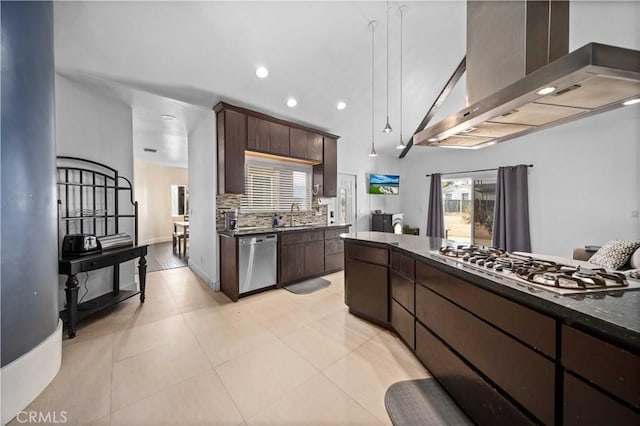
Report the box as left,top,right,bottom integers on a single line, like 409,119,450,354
342,232,640,352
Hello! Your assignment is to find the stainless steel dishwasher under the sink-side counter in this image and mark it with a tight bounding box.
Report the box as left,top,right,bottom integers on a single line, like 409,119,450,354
238,234,278,294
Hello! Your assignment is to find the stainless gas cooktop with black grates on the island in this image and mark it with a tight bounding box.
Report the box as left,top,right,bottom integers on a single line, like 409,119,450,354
432,245,640,295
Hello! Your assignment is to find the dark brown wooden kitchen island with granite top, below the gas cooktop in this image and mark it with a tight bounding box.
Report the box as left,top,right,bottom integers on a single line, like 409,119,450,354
341,232,640,425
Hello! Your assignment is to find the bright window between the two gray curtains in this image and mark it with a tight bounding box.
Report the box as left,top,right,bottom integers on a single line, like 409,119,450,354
442,176,496,246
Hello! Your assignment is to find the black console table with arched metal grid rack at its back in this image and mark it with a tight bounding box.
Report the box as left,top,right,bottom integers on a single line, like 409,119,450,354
57,156,148,338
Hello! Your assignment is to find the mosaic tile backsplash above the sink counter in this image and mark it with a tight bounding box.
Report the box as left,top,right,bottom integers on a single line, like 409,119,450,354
216,194,327,231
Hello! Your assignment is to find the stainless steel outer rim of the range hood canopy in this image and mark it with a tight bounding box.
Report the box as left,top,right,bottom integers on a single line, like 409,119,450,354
413,43,640,149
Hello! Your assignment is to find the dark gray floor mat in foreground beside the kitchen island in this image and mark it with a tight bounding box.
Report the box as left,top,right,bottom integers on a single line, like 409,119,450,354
384,378,473,426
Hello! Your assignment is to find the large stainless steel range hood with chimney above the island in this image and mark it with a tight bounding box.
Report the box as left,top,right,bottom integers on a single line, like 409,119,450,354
413,0,640,149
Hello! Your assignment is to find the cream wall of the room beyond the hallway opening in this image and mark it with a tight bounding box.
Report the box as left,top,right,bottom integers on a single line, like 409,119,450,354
134,159,189,244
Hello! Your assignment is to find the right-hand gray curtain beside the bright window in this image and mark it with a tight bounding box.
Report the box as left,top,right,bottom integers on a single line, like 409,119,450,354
492,164,531,252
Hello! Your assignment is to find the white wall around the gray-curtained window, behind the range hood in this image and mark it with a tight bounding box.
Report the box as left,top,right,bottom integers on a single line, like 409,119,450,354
398,2,640,256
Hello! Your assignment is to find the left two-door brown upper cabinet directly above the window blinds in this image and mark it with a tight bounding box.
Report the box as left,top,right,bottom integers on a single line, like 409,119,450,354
247,116,290,157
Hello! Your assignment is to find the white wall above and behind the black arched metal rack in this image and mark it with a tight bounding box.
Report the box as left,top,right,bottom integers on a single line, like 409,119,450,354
55,74,136,308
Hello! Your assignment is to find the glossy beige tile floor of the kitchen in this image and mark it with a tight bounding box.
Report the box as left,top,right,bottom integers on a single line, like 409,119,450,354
10,268,428,425
